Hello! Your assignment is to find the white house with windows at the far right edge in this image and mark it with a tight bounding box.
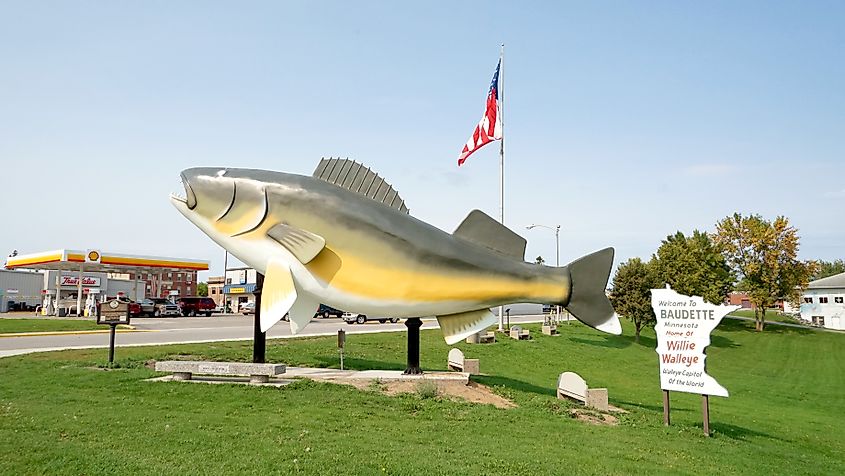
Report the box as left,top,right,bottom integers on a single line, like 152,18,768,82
801,273,845,330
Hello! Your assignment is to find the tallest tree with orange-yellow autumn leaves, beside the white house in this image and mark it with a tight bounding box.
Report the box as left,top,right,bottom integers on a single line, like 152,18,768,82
714,213,818,331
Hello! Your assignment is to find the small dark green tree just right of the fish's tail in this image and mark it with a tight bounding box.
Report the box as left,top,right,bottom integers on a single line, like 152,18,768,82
610,258,657,344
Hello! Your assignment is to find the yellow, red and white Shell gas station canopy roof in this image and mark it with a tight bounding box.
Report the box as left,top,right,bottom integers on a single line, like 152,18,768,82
6,249,208,273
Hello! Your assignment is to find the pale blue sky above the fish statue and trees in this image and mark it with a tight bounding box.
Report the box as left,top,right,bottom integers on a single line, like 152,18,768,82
0,1,845,273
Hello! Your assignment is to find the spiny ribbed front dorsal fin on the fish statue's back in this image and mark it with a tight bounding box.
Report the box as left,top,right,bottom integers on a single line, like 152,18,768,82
313,157,410,213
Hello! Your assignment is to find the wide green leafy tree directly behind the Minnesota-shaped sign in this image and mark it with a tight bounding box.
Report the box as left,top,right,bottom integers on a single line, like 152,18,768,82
652,230,734,304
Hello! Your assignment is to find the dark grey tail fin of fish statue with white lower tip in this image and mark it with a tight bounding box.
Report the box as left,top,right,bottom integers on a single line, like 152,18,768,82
566,248,622,335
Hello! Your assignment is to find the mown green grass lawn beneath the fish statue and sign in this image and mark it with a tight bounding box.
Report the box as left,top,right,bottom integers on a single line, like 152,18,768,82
0,321,845,475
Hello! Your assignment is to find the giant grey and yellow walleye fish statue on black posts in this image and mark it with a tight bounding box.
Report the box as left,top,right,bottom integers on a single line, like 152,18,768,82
171,159,621,344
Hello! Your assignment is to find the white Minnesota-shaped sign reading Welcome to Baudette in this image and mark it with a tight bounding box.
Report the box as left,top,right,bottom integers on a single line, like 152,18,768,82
651,287,740,397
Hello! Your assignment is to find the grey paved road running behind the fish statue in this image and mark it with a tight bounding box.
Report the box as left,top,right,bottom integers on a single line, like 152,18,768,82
0,314,543,357
